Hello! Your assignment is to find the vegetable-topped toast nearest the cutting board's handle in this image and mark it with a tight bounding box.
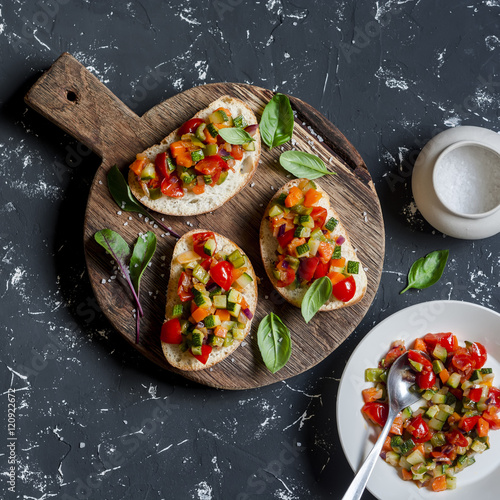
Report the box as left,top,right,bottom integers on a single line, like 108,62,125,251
128,96,260,215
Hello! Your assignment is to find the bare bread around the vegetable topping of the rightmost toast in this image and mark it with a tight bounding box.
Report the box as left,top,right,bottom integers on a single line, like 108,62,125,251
260,179,367,311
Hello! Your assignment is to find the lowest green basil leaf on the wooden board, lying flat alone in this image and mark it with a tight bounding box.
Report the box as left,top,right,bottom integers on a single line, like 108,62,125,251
257,313,292,373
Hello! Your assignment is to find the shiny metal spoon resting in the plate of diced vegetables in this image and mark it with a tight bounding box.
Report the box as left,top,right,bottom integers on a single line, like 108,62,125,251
342,353,422,500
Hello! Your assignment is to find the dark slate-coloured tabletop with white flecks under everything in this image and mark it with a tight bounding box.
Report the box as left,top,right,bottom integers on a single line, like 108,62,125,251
0,0,500,500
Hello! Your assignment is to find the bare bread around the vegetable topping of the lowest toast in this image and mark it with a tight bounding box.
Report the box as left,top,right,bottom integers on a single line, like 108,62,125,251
162,229,257,371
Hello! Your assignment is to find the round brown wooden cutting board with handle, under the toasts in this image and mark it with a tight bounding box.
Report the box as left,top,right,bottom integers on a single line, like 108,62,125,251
25,53,385,389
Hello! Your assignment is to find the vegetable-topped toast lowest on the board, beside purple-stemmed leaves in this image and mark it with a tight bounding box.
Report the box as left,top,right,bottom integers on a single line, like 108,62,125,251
161,230,257,370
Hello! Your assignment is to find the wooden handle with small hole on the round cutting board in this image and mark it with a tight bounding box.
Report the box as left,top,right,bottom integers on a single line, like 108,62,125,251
24,52,144,158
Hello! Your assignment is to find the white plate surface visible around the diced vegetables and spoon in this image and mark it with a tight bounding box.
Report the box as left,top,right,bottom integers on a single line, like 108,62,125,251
336,300,500,500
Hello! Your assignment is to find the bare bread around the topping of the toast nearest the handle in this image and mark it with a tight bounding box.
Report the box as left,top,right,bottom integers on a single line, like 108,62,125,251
128,95,261,216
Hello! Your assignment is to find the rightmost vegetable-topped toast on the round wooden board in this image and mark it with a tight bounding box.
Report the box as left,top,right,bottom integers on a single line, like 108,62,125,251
260,179,367,311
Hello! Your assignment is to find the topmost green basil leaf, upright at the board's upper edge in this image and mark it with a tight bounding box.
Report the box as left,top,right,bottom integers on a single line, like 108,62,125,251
259,94,294,149
